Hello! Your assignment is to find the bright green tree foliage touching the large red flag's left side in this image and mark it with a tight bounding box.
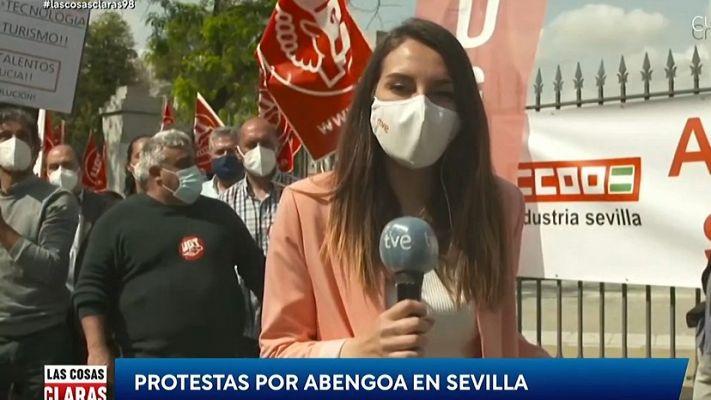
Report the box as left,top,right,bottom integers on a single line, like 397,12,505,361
146,0,276,123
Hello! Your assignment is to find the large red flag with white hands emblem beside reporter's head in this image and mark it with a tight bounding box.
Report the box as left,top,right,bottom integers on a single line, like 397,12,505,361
257,0,371,160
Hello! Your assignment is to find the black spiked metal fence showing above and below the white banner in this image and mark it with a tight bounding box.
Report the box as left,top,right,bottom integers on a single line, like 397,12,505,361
517,47,711,358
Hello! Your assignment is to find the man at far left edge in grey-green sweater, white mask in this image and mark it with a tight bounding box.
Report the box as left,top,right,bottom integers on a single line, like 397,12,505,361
0,108,79,399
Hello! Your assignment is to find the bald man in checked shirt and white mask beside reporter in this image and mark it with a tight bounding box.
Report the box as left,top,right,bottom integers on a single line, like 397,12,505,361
220,118,295,355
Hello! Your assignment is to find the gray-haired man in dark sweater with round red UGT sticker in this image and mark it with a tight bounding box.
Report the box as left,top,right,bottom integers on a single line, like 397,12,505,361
74,130,264,368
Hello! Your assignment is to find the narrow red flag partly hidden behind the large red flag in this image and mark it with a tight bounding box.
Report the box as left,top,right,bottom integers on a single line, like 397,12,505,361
258,61,301,173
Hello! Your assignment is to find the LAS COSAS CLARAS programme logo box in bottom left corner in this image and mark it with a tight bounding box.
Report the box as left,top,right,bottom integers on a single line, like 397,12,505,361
44,365,106,400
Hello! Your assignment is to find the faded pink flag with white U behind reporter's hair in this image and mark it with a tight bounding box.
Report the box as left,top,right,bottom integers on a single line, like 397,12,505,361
417,0,546,183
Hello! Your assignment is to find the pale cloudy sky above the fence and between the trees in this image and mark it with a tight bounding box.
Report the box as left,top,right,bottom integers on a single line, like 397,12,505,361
92,0,711,102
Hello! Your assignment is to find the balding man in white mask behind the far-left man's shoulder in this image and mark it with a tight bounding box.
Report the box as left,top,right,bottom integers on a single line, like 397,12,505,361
45,144,115,364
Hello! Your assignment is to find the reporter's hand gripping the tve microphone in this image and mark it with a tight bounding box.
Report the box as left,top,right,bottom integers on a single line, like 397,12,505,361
341,300,434,358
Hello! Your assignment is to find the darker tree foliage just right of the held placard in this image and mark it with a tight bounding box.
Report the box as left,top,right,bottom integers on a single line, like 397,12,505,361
66,12,138,151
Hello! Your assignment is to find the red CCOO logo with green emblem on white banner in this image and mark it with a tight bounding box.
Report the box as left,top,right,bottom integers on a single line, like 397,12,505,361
518,157,642,203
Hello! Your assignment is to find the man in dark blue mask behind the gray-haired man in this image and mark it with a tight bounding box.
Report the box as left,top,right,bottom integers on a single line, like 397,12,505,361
202,126,244,199
